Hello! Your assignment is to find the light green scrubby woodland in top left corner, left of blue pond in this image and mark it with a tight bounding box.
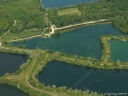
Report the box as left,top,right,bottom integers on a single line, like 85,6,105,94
0,0,46,34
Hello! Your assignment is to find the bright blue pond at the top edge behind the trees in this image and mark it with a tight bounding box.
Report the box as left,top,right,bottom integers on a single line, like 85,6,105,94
42,0,97,8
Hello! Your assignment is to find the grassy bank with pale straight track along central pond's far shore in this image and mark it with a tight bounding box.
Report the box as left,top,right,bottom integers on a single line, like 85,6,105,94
0,19,111,42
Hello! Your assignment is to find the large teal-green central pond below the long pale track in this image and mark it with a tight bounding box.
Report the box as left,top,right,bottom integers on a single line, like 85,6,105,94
12,24,123,59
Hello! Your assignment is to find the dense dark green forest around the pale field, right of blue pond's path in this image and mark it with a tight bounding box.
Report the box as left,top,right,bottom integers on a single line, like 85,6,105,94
47,0,128,33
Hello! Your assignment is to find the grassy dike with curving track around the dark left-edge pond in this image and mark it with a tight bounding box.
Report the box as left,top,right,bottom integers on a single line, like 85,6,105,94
0,47,54,96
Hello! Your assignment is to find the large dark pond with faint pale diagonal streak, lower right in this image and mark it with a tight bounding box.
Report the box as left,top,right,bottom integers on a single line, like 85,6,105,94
37,61,128,96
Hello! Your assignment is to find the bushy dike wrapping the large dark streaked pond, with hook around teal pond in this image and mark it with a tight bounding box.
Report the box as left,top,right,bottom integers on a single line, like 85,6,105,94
8,36,128,96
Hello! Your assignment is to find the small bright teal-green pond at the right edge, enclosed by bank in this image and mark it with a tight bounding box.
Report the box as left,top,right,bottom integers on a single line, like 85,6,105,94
109,40,128,62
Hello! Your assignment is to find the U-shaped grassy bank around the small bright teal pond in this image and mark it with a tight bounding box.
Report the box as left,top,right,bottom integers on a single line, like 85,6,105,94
100,36,128,69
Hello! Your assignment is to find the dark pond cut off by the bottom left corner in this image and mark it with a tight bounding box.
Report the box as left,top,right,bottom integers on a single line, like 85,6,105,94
0,85,29,96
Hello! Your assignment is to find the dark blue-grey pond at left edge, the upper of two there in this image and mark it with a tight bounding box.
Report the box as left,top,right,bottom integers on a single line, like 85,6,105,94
0,53,28,76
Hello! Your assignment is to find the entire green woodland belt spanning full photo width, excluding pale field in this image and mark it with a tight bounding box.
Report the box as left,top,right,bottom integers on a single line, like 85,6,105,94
0,0,128,35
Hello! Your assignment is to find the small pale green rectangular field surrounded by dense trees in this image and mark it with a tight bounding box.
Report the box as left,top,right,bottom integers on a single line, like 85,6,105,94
58,8,81,16
